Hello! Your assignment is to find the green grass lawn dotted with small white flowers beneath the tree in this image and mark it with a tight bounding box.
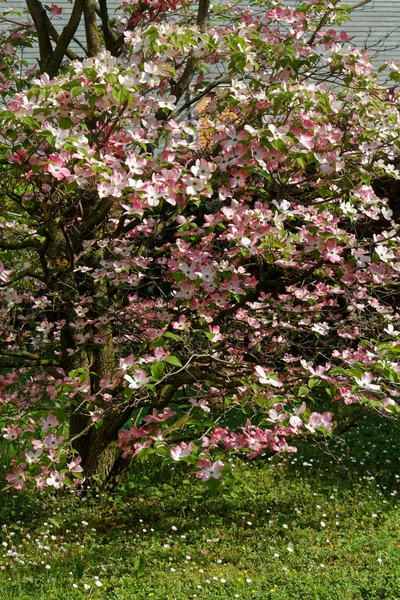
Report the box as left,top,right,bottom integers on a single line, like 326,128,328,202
0,420,400,600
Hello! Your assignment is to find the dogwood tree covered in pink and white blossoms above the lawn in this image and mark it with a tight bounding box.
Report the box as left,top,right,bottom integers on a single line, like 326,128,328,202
0,0,400,489
